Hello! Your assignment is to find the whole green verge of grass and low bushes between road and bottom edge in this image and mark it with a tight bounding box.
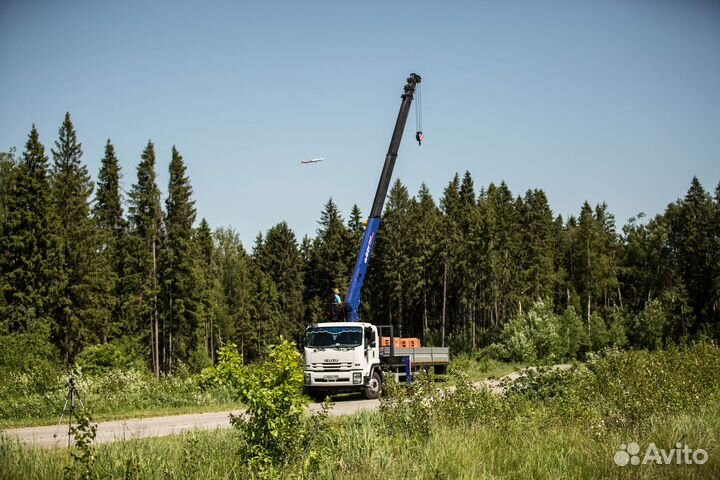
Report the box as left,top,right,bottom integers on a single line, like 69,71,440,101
0,345,720,479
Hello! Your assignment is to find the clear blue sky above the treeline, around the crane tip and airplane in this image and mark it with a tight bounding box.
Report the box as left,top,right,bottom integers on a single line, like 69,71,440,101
0,0,720,246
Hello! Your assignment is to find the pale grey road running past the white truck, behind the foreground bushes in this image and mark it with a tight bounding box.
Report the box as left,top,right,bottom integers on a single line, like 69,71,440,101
4,365,570,448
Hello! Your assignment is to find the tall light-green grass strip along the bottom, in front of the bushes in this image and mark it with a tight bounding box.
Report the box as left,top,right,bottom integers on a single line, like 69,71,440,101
0,396,720,480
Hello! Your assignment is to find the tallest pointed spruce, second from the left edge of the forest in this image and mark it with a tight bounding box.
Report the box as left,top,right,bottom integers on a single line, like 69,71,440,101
51,113,100,363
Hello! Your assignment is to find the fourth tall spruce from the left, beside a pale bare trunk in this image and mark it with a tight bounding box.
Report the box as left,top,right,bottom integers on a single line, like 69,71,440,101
126,141,167,377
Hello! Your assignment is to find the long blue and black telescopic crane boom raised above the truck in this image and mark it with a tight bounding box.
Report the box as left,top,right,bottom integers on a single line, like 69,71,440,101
345,73,420,322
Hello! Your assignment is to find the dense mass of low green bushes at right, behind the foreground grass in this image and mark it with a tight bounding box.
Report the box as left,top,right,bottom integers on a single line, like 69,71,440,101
503,343,720,426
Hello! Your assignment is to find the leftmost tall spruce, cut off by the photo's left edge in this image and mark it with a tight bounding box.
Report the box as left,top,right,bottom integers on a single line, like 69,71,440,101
0,125,61,338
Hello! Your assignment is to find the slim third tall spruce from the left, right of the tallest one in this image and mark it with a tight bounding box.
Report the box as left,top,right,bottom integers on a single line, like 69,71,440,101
92,140,127,342
